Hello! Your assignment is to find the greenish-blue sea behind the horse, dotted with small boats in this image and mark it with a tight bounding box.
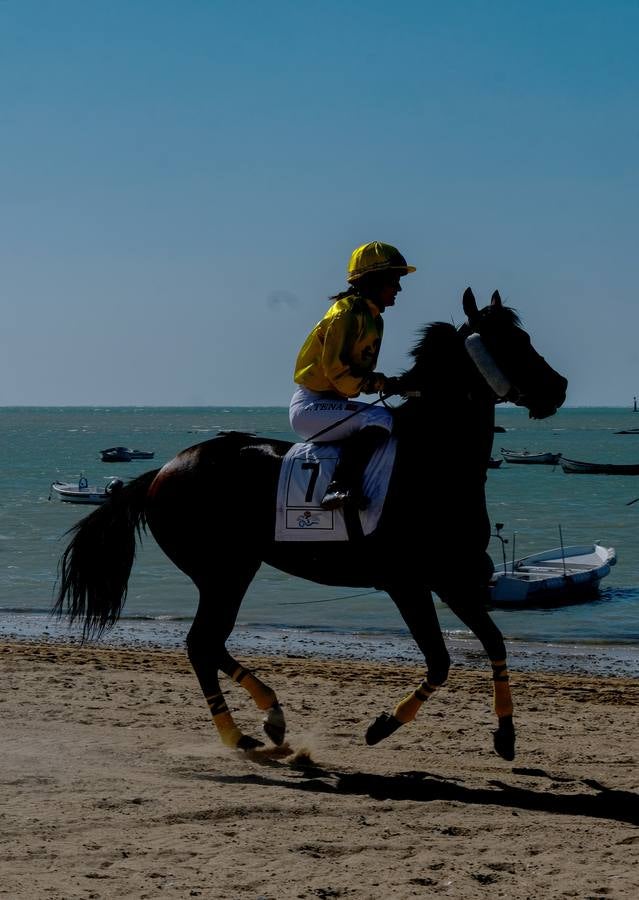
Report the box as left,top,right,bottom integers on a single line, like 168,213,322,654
0,406,639,677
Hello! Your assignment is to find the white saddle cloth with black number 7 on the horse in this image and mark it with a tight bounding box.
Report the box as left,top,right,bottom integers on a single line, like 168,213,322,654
275,437,396,541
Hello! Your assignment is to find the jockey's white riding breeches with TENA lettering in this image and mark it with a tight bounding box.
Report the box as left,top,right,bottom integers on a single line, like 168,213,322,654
289,387,393,443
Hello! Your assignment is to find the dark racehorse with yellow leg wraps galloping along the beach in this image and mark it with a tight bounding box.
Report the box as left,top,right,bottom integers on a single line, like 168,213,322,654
54,288,568,760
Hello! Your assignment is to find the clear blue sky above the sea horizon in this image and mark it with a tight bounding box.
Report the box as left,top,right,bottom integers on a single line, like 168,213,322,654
0,0,639,406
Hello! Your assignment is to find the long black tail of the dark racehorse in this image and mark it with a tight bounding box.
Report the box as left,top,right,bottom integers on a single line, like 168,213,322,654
53,469,159,640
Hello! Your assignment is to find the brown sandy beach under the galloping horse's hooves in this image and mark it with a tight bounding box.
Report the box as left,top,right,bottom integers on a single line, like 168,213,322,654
0,641,639,900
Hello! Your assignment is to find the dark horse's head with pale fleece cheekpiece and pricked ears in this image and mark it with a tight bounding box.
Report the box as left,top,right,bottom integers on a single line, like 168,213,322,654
460,288,568,419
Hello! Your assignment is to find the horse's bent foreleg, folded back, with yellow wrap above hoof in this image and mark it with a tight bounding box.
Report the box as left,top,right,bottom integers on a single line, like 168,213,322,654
366,588,450,745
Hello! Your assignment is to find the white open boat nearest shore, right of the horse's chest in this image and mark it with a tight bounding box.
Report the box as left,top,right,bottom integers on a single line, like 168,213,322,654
490,543,617,607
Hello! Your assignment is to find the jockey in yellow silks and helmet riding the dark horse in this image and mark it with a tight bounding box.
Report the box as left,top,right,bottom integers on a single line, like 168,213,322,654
289,241,415,509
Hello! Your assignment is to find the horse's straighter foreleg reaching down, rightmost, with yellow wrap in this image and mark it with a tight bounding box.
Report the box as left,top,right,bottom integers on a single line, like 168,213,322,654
445,591,515,761
